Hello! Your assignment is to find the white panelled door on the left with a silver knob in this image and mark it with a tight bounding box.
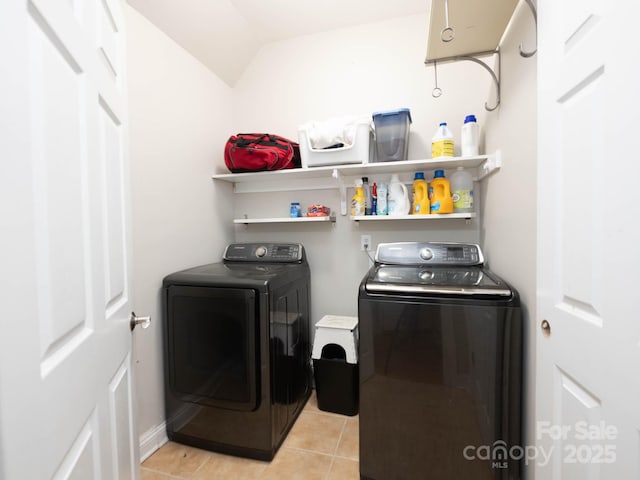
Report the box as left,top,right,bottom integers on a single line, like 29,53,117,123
0,0,139,480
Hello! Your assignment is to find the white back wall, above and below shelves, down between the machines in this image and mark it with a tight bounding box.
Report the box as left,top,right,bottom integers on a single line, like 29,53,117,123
232,15,490,330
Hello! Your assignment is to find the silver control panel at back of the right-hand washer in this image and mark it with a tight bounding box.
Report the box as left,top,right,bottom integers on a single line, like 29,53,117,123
376,242,484,266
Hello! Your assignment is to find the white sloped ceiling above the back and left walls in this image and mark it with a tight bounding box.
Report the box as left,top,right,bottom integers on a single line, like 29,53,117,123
127,0,431,86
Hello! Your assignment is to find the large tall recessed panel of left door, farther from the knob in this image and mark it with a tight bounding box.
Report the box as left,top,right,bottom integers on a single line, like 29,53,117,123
28,0,88,364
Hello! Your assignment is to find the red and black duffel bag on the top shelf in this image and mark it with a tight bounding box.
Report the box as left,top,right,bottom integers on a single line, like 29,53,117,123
224,133,300,173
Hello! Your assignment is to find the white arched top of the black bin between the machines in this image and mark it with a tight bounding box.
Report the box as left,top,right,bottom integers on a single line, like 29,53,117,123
311,315,358,365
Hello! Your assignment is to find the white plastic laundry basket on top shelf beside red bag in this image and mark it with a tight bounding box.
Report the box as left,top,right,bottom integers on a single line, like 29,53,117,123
298,121,373,168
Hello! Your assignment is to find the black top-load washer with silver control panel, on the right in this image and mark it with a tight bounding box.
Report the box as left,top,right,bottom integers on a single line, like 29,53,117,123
358,242,523,480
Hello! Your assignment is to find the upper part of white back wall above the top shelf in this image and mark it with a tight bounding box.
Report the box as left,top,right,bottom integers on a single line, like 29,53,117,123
233,15,490,159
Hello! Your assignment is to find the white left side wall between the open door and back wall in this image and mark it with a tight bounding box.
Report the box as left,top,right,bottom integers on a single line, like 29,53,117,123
126,7,232,458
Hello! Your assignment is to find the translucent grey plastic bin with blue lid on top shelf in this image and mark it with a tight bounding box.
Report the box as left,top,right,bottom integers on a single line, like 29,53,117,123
373,108,411,162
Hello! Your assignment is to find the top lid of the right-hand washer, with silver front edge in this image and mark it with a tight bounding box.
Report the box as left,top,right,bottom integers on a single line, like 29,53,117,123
365,265,513,297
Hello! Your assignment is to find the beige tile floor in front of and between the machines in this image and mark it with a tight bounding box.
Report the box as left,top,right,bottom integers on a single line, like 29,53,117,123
142,392,360,480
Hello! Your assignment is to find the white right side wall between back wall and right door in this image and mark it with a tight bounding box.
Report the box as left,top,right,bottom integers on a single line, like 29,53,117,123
481,2,538,478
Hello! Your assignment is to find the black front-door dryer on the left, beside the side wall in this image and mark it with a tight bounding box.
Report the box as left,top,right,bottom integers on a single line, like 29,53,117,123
163,243,311,460
